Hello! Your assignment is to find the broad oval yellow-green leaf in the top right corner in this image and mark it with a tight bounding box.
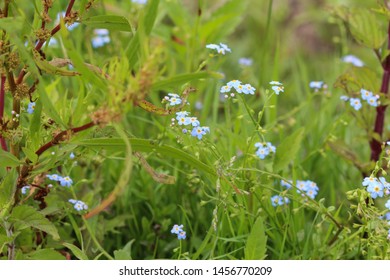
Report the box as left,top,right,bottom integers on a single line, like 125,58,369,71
348,8,386,49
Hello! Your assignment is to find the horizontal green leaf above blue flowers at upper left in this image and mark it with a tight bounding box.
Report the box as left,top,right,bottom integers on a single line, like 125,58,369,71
82,15,132,32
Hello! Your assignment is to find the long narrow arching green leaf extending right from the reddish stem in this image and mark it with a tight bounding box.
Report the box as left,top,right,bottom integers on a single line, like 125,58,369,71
72,138,216,176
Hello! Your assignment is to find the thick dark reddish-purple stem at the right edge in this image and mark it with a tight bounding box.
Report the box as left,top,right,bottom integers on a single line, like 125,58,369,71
370,22,390,161
